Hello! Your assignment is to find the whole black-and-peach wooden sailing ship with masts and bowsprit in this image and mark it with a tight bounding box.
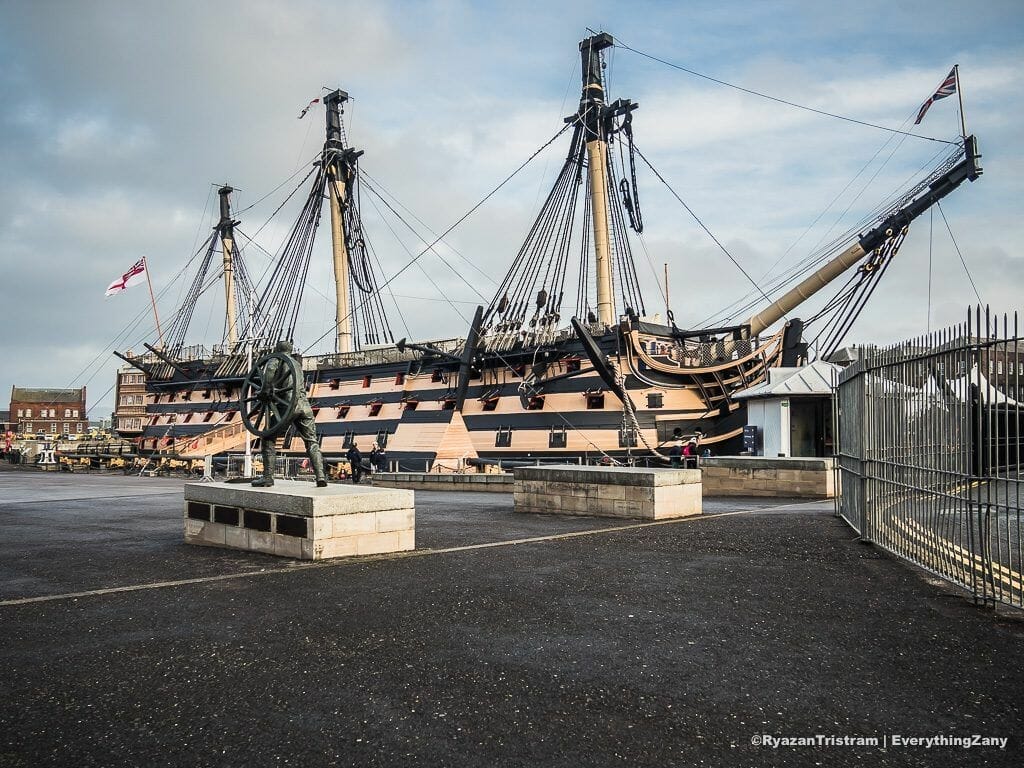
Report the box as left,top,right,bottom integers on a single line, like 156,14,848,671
122,35,981,471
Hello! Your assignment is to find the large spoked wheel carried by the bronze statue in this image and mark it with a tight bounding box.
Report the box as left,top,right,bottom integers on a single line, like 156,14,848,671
239,352,303,438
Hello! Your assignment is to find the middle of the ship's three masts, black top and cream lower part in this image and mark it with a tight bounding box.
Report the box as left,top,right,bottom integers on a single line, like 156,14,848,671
324,90,353,352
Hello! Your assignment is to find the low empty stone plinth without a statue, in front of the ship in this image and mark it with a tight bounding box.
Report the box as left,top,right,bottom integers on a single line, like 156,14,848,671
514,465,701,520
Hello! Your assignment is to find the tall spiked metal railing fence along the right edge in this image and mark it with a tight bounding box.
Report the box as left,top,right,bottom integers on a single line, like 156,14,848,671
837,308,1024,607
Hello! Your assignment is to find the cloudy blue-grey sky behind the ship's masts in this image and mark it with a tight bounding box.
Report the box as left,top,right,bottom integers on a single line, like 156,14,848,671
0,0,1024,419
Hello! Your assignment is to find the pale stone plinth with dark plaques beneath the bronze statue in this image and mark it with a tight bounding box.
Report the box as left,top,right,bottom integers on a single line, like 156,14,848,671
184,480,416,560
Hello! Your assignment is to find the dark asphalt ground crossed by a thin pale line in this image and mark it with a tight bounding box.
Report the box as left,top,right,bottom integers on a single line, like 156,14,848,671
0,470,1024,768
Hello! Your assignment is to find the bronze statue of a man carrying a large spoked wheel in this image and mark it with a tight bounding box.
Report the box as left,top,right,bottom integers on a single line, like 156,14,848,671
239,341,327,488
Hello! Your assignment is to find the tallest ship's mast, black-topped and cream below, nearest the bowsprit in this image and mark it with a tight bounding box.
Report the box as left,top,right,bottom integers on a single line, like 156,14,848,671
579,33,615,326
